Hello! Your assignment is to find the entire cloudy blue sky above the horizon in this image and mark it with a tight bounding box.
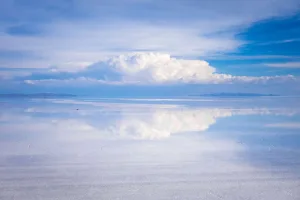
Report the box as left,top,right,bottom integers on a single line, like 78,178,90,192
0,0,300,96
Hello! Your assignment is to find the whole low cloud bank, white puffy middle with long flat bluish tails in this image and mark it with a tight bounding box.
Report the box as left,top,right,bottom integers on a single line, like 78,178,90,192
23,53,295,84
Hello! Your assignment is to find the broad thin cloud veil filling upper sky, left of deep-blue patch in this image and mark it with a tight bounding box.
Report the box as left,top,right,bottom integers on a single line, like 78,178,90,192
0,0,299,68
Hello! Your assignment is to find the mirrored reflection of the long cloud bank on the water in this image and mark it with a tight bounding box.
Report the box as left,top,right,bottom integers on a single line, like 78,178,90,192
0,101,295,140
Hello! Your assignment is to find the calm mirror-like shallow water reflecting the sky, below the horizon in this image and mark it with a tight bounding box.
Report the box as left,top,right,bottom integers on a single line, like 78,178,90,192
0,97,300,200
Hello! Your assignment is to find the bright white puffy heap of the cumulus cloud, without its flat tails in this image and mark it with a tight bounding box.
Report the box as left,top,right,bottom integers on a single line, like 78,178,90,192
99,53,216,82
